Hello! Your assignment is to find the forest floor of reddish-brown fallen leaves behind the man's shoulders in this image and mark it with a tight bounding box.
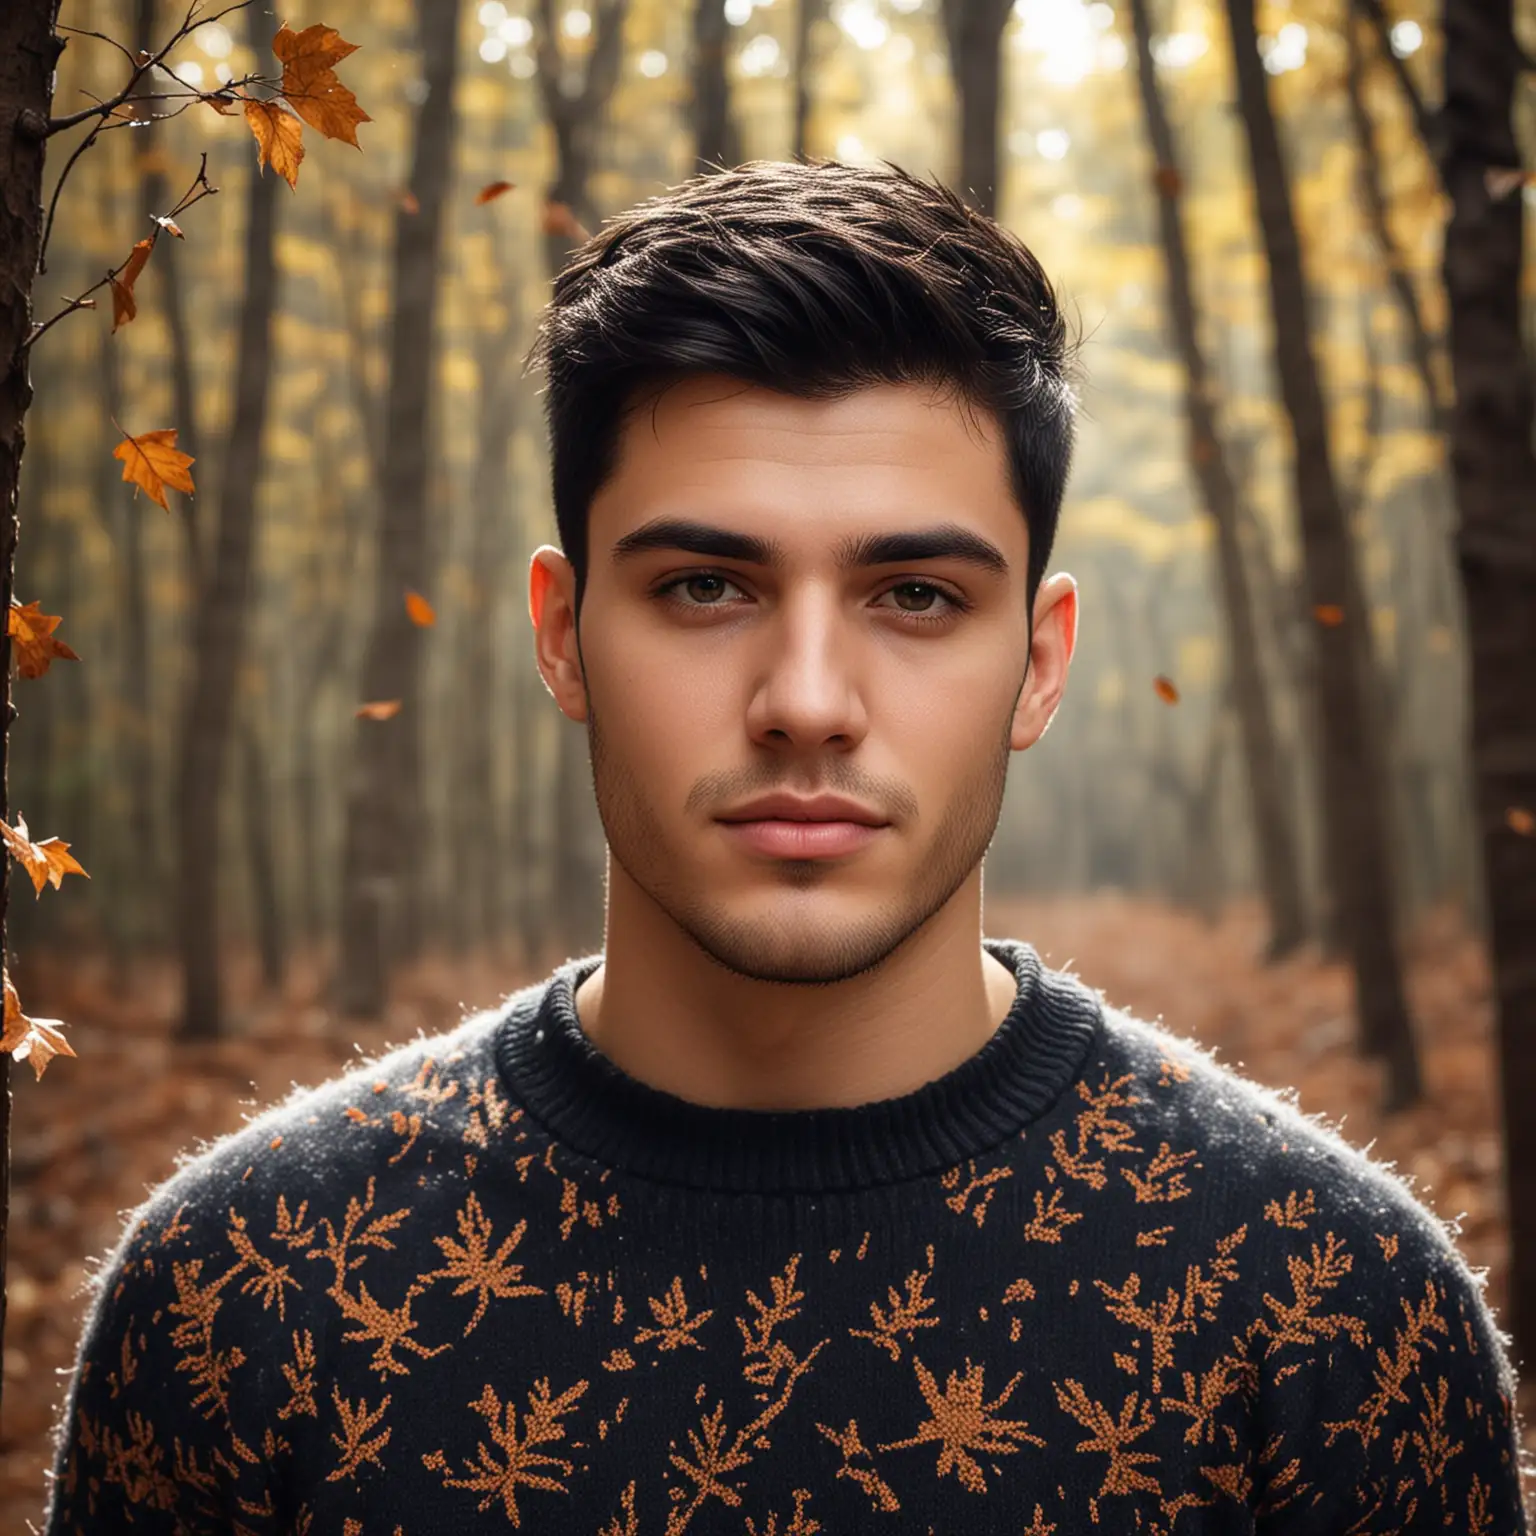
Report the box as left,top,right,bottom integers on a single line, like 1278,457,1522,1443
0,892,1536,1531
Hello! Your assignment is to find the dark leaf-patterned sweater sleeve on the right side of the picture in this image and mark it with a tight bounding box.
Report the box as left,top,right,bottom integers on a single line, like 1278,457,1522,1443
1258,1190,1530,1536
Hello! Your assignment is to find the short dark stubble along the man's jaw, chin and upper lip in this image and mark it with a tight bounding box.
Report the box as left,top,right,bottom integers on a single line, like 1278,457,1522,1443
587,703,1023,986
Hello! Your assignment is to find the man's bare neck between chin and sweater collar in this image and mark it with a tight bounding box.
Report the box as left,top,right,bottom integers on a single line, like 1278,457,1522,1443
576,862,1015,1109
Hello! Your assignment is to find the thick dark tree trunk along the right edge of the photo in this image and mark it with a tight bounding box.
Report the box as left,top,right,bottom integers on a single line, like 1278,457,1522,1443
1441,0,1536,1352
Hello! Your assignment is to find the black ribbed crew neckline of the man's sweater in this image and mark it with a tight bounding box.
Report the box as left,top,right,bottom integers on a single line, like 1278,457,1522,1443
496,938,1101,1195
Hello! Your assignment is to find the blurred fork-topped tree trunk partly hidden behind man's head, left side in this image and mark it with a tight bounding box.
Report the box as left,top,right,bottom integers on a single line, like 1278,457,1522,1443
536,0,628,951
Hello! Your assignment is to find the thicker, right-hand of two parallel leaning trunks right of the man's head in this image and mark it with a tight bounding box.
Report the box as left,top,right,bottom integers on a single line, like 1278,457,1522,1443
1227,0,1419,1111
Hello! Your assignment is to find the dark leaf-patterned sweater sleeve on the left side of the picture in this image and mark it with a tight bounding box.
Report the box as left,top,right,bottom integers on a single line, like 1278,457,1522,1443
46,1198,275,1536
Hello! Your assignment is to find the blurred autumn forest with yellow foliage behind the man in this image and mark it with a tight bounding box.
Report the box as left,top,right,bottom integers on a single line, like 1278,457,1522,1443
0,0,1536,1530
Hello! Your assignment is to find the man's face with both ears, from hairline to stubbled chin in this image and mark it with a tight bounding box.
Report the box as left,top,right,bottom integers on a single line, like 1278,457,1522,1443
533,375,1075,983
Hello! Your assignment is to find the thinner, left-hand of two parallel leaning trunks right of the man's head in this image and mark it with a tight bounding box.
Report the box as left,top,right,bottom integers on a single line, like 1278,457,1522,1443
1130,0,1307,958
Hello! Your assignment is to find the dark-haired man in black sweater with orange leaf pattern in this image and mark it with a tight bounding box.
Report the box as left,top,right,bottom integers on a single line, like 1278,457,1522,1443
51,163,1525,1536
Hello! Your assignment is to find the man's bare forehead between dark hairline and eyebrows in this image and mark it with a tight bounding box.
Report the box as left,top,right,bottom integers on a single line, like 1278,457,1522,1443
590,375,1025,553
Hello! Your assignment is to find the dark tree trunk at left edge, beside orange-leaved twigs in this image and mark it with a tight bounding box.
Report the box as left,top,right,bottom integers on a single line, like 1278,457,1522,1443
0,0,65,1413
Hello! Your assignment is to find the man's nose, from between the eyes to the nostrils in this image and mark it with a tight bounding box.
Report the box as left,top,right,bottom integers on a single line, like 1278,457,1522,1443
746,591,869,751
